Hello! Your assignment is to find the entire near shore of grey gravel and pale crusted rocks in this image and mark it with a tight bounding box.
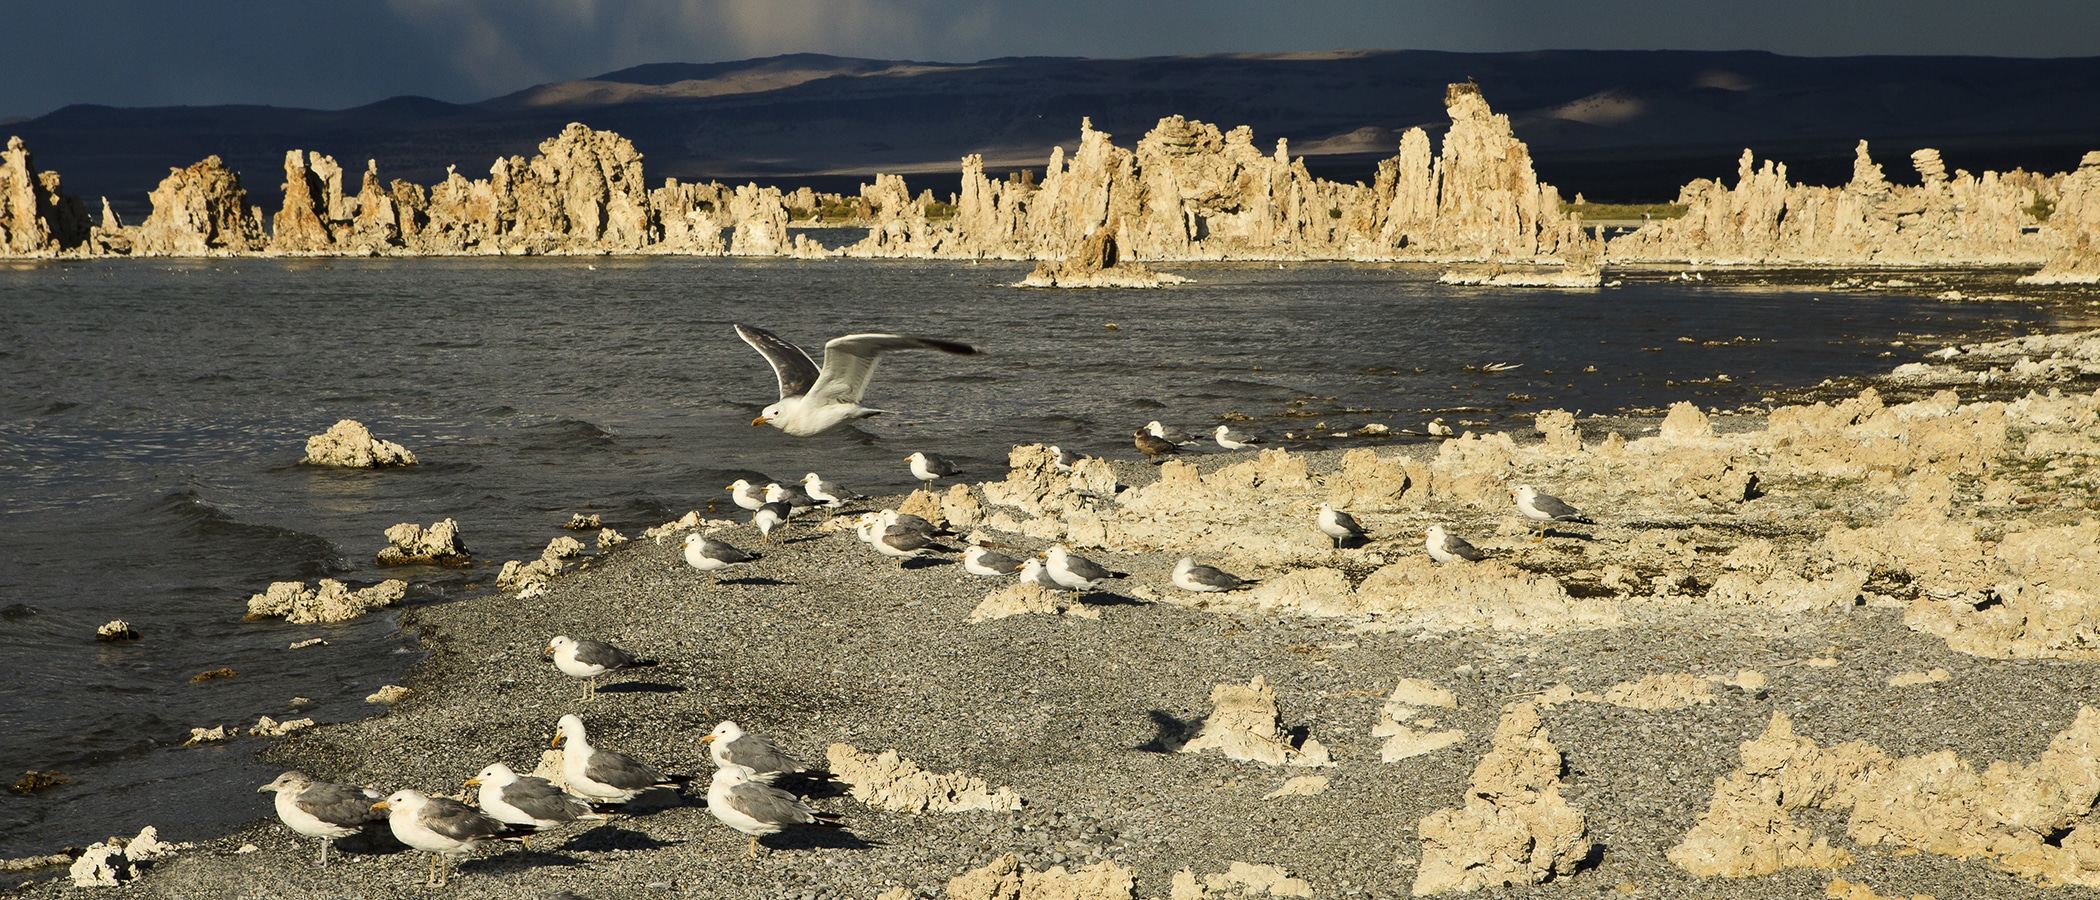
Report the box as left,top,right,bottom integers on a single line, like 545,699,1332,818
21,334,2100,900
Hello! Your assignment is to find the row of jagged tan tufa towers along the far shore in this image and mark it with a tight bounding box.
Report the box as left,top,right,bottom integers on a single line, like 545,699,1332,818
0,82,2100,285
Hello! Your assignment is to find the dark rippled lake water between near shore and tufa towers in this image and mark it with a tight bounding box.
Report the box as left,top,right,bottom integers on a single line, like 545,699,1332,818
0,258,2050,856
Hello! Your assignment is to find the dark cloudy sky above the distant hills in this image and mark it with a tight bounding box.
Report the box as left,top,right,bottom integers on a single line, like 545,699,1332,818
0,0,2100,117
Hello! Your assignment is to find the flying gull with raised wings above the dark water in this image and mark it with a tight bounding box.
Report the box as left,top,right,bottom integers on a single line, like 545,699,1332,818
737,325,979,438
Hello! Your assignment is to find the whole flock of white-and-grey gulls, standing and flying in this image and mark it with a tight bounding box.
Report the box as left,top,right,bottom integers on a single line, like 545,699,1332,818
258,325,1594,885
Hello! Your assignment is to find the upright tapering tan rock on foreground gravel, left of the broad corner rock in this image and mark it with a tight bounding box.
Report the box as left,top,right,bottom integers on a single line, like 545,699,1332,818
1413,703,1590,896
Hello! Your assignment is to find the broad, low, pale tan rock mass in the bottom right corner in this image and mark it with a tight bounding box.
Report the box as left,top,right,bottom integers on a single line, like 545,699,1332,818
1667,707,2100,887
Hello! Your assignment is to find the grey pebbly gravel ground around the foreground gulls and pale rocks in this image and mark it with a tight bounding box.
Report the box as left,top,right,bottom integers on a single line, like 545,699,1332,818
19,411,2100,900
